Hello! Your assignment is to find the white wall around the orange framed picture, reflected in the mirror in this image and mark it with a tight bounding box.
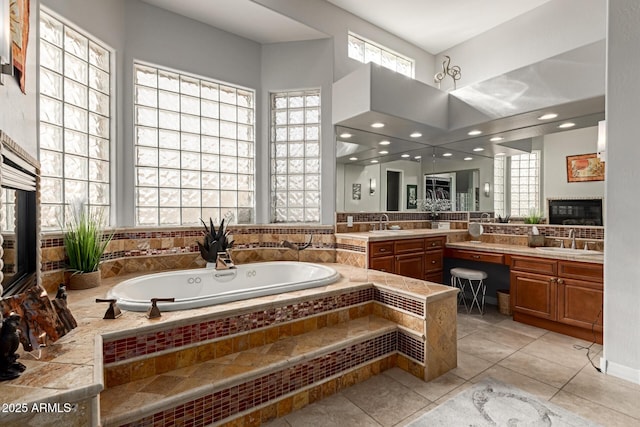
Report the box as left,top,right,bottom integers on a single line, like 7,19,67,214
542,127,604,201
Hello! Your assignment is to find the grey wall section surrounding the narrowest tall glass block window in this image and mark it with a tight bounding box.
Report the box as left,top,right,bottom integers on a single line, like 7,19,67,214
256,39,336,224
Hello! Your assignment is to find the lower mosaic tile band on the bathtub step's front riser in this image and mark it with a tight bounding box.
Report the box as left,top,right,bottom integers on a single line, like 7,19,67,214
116,331,398,427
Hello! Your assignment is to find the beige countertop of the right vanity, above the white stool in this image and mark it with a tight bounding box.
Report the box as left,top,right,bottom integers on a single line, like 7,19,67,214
447,241,604,264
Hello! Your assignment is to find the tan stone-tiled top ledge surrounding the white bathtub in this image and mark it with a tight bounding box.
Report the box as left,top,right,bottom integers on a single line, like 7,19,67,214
0,260,452,424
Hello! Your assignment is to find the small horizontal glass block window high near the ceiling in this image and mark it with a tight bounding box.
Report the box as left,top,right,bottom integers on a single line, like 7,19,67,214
347,32,415,78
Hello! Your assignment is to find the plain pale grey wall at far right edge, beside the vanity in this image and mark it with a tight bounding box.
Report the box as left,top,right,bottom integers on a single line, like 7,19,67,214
600,0,640,384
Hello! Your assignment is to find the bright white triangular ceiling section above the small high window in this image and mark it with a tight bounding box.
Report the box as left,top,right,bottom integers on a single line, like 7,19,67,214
327,0,550,55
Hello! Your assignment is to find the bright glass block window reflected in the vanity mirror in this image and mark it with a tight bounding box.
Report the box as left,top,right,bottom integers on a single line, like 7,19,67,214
494,150,541,217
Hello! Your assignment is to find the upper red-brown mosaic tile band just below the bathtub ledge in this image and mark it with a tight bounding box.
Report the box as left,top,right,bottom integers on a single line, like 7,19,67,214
102,286,425,364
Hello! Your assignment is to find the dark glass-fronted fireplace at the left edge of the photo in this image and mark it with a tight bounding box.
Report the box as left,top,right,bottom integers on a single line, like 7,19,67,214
2,158,38,297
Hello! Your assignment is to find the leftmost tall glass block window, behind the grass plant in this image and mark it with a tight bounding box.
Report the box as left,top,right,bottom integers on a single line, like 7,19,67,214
39,11,111,231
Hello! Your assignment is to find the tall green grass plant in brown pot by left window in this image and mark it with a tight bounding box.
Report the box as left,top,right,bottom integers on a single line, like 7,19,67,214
64,205,113,289
